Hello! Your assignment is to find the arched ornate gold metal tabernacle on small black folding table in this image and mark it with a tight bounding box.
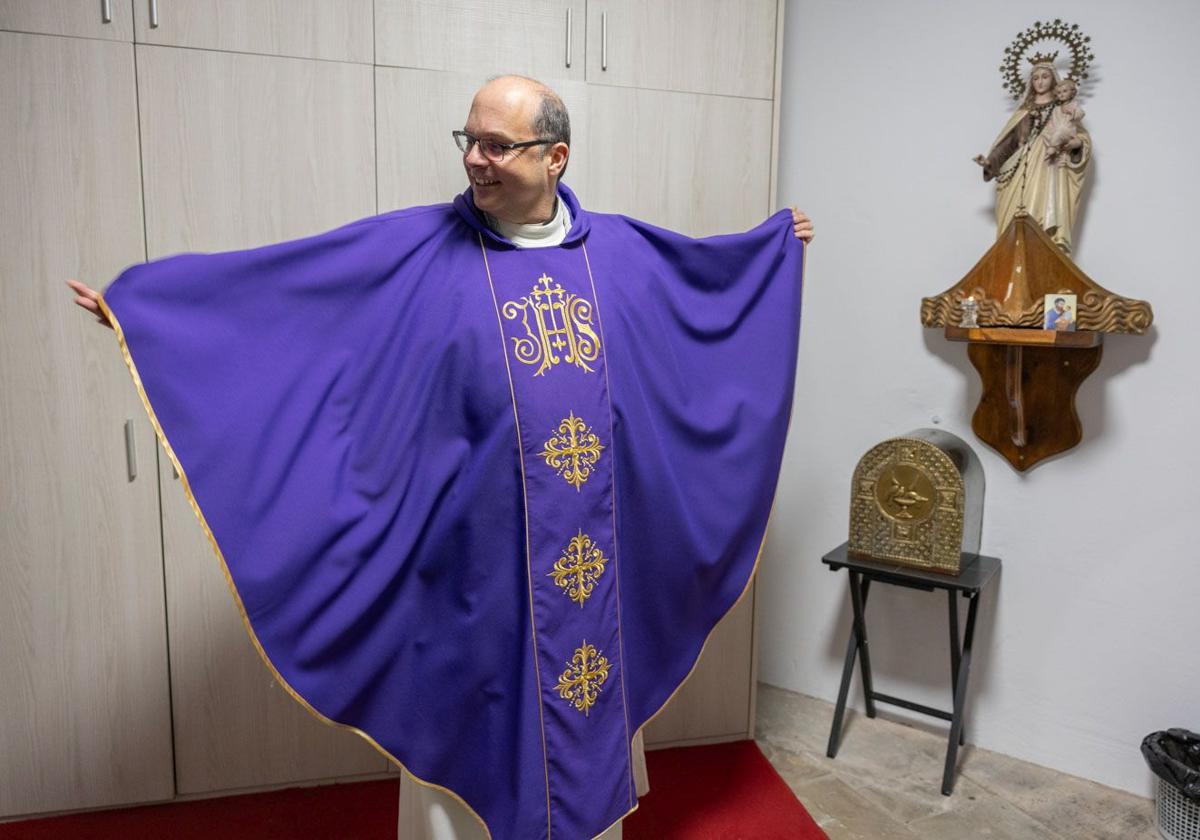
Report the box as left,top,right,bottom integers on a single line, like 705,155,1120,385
850,428,984,575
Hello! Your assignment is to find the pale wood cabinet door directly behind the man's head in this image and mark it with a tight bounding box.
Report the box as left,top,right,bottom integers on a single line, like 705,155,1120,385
376,67,589,211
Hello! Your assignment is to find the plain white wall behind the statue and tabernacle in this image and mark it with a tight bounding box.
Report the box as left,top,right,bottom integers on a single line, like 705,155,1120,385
758,0,1200,796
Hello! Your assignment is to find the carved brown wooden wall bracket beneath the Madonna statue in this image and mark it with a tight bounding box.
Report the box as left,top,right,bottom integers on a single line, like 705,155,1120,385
920,214,1154,472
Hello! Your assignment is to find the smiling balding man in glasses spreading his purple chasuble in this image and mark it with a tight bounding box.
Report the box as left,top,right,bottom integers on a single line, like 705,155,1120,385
71,77,812,839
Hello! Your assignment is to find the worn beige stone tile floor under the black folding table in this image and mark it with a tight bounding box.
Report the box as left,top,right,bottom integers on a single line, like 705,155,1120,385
756,683,1158,840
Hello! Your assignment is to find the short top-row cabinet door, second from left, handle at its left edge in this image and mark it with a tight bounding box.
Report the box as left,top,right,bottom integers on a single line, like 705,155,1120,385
129,0,372,64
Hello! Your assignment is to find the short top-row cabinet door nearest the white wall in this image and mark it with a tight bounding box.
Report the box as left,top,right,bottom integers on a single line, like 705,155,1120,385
587,0,778,100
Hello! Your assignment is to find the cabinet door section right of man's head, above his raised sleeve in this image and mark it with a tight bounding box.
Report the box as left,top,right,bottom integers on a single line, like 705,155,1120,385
588,85,772,236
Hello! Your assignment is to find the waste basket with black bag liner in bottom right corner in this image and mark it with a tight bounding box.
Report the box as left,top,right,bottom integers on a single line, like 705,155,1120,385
1141,730,1200,840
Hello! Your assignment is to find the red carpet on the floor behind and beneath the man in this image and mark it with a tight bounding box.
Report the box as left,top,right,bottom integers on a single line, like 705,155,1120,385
0,740,826,840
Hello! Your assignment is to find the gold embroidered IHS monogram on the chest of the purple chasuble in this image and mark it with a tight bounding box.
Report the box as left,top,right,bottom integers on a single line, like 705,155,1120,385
500,274,600,377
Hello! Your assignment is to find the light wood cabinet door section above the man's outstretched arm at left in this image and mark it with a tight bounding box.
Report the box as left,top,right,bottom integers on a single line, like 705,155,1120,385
137,46,376,253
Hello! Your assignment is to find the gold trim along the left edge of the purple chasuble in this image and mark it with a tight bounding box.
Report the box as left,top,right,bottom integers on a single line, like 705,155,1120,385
87,293,492,840
